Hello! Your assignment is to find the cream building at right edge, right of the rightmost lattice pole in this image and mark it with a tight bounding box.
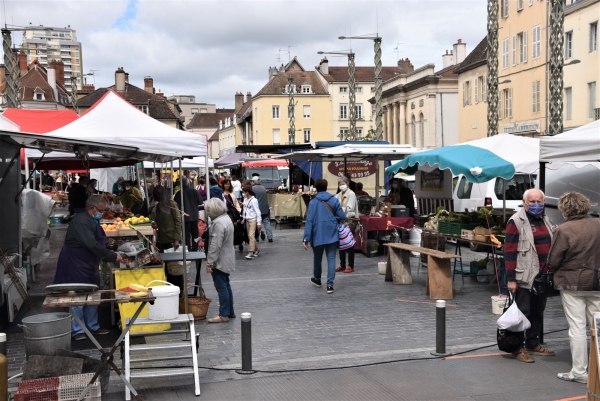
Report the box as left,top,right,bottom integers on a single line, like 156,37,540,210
563,0,600,129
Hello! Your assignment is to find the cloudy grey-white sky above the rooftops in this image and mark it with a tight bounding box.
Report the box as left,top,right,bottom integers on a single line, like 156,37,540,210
0,0,486,108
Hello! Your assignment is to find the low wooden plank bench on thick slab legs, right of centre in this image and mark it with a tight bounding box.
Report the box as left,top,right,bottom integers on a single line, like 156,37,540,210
385,243,461,299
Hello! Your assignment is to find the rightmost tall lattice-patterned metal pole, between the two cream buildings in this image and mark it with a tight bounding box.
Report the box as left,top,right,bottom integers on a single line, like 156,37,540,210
548,0,565,135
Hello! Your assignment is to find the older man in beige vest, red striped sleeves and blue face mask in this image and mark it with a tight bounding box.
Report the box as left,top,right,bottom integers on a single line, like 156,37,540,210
504,188,554,363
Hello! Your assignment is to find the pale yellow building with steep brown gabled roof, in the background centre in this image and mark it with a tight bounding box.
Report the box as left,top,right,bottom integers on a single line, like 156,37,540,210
248,58,332,145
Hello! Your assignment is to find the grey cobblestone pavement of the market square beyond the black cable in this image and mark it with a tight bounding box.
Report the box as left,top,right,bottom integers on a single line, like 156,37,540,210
8,223,577,399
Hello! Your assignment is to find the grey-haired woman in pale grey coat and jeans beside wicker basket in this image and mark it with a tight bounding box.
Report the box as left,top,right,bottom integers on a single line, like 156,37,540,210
204,198,235,323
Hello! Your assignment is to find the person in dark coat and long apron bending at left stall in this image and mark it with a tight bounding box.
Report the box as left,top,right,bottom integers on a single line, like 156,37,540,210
54,194,122,341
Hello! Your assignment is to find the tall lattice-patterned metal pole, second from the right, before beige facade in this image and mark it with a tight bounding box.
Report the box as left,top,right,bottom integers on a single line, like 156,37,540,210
487,0,499,136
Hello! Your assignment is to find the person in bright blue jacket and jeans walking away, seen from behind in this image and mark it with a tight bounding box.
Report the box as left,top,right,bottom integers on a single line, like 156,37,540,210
302,178,346,294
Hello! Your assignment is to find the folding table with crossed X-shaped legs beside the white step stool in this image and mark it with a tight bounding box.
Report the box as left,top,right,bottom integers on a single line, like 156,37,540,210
42,290,156,401
